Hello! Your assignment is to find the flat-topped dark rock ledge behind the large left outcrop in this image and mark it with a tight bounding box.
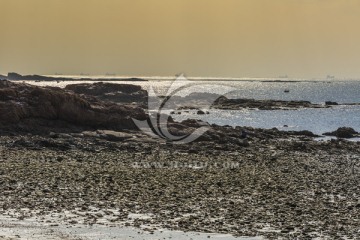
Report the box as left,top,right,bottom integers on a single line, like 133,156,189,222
65,82,148,104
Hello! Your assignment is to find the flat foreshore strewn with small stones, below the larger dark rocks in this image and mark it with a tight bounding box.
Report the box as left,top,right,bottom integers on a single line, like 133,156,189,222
0,130,360,239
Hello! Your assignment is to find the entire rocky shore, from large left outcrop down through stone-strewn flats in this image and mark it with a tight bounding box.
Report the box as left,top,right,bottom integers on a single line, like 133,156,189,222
0,81,360,239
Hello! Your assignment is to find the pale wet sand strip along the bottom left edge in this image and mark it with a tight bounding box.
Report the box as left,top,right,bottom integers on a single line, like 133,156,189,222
0,213,263,240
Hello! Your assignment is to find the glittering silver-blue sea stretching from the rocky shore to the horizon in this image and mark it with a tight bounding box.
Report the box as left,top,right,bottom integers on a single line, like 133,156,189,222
25,76,360,141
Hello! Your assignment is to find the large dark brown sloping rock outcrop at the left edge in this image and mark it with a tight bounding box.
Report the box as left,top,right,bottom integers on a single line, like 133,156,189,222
0,81,147,129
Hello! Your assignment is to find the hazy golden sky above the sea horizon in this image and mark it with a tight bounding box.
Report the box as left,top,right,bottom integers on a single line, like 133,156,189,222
0,0,360,77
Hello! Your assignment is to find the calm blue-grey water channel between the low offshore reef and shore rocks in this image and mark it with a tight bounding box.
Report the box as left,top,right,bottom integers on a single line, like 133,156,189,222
172,106,360,135
